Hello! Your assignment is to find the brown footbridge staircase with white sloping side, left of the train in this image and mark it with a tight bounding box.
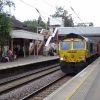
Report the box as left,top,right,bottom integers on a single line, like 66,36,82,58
29,28,58,55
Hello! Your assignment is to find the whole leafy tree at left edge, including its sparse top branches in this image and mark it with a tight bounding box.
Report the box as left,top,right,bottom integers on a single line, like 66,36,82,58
0,0,15,51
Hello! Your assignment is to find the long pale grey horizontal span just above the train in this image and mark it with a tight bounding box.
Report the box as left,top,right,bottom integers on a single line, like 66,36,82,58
58,26,100,36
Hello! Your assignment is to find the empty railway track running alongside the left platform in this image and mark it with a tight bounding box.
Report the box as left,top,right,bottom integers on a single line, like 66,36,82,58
0,65,60,94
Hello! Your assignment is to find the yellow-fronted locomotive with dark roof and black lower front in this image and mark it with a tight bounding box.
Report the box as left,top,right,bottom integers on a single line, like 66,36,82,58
59,33,98,74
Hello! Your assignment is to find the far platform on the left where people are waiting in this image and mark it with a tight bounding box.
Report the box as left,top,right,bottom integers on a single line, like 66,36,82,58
0,55,59,70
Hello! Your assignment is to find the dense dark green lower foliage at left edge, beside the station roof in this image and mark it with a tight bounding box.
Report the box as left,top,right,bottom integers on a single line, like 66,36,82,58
0,13,12,50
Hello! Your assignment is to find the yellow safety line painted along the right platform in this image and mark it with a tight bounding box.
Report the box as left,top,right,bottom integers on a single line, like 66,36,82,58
66,63,96,100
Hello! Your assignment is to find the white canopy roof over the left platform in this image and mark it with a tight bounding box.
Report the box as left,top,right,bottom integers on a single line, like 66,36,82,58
10,30,44,40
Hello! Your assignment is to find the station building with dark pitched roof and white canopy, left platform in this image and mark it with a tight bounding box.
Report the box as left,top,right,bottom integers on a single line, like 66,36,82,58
5,17,44,57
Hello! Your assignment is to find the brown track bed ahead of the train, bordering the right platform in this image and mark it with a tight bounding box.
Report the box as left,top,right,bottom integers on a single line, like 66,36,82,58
23,76,73,100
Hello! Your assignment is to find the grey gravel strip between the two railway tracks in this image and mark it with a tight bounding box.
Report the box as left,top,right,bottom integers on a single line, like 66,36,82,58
0,71,65,100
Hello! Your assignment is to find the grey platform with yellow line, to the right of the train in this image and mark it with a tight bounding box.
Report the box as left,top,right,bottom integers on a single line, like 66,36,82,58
44,57,100,100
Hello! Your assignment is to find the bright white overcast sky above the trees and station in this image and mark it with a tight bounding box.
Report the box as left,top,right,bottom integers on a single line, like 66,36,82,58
10,0,100,27
